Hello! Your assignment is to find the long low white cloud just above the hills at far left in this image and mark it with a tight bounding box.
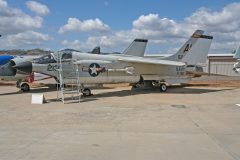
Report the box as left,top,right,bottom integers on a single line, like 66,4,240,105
0,31,52,48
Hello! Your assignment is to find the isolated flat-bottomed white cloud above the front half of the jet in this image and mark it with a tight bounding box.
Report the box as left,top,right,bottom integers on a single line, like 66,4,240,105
59,18,110,33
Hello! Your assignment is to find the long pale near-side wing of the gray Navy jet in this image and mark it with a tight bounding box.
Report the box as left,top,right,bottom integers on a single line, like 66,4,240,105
118,57,186,66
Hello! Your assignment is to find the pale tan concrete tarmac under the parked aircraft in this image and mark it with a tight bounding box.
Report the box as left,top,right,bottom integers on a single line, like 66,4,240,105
0,86,240,160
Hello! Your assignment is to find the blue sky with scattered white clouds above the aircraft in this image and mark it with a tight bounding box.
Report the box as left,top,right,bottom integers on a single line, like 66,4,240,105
0,0,240,53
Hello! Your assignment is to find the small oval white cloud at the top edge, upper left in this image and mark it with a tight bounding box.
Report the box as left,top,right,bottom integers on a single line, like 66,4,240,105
26,1,50,16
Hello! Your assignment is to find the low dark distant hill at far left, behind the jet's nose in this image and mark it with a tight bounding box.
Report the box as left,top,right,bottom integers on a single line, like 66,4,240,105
0,48,52,55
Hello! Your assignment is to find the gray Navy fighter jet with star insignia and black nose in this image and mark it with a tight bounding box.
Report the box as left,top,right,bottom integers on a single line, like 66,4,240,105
15,30,213,95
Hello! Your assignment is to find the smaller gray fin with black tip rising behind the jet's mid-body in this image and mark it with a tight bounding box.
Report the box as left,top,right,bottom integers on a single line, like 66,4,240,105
123,39,148,57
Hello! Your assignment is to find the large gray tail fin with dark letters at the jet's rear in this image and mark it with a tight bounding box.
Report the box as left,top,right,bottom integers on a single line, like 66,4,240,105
166,30,213,65
